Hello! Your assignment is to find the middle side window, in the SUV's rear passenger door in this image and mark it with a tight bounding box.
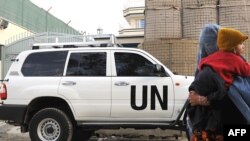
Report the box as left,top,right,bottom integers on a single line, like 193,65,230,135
66,52,106,76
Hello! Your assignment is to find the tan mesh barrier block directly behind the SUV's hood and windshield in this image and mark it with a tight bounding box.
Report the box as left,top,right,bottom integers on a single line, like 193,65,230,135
141,39,198,75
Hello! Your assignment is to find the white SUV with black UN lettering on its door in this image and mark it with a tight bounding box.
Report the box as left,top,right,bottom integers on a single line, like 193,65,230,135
0,44,193,141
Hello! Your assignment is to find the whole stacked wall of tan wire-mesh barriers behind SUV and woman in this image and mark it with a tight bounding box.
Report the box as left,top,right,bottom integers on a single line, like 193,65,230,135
144,0,250,75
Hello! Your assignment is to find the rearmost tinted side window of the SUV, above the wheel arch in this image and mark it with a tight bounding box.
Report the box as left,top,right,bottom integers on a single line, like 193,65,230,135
21,51,68,76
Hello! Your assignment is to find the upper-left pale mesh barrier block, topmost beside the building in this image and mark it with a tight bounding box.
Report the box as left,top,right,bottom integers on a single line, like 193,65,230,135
145,7,182,40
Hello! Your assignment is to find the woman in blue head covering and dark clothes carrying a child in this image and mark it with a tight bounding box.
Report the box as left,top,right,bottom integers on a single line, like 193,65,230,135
187,24,245,141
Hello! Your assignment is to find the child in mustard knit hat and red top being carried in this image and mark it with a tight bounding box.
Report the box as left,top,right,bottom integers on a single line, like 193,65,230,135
199,28,250,124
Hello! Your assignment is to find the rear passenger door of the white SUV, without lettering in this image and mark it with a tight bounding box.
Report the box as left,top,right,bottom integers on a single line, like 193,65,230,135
59,50,111,119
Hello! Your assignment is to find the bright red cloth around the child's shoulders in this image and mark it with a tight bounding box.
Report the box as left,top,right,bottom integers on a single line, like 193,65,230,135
199,51,250,87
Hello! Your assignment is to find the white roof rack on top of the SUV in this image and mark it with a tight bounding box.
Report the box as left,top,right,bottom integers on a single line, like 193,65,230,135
32,34,121,49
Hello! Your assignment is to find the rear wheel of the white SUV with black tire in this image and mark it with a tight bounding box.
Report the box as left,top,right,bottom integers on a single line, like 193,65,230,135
29,108,73,141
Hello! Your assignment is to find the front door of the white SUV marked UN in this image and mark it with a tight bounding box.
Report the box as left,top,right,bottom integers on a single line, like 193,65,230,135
111,51,174,120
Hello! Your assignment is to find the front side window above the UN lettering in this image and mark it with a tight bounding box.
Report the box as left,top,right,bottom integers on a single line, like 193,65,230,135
115,52,155,76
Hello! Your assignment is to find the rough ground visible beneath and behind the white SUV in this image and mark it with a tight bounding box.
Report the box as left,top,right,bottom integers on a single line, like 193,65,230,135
0,121,187,141
